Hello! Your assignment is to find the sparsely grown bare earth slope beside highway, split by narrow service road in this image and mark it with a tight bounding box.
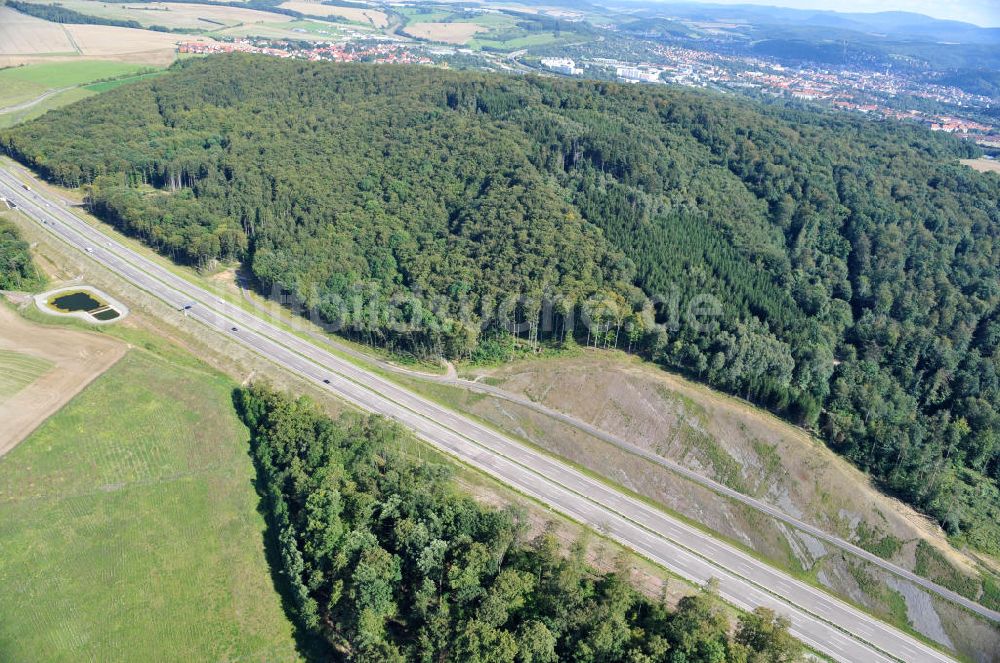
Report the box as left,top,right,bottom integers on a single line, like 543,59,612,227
450,352,1000,662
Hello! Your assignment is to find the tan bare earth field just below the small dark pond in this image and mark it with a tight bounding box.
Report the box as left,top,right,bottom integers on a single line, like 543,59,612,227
0,305,126,456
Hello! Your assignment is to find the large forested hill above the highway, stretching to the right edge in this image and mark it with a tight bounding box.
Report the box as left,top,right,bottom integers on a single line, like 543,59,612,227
0,56,1000,553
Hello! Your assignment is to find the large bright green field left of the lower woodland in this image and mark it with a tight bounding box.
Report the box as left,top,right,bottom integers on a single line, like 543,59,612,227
0,350,299,663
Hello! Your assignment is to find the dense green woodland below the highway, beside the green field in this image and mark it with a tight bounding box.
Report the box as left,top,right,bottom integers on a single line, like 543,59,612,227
236,386,802,663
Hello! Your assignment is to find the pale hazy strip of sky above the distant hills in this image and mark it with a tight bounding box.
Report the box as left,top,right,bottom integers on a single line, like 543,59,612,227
680,0,1000,27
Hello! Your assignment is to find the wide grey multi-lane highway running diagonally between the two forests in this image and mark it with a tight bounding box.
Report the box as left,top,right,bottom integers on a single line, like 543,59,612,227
0,163,953,663
